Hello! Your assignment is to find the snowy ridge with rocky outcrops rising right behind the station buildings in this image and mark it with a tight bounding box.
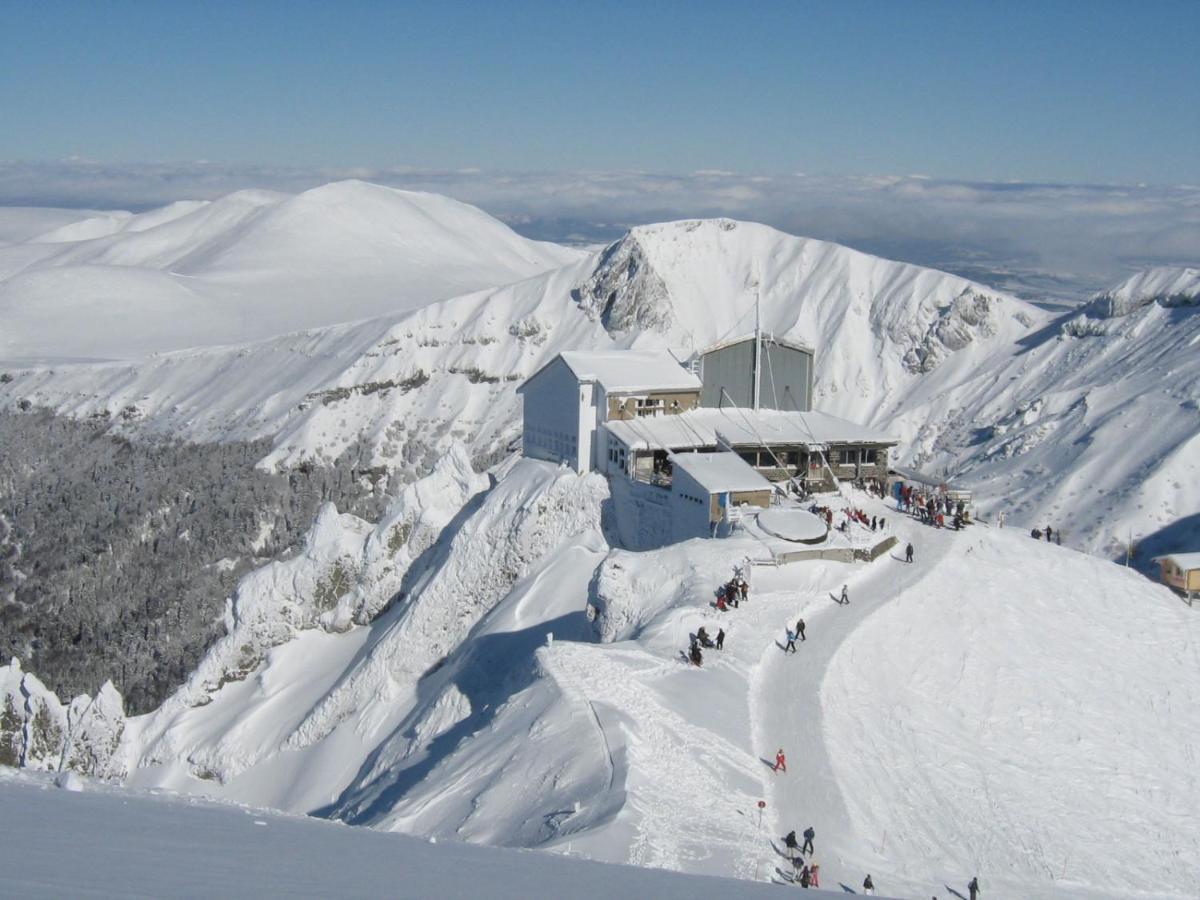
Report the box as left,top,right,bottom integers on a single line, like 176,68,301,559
7,213,1200,552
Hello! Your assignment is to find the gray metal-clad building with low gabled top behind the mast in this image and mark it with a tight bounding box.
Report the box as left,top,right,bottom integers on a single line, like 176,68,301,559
697,335,812,413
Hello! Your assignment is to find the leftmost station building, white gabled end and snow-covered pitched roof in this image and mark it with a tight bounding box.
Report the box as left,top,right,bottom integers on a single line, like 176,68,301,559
517,350,701,473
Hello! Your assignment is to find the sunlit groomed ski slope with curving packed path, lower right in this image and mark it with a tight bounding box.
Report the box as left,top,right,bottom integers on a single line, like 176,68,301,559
754,499,1200,898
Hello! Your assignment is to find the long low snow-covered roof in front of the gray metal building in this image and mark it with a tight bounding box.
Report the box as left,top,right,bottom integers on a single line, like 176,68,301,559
605,407,900,450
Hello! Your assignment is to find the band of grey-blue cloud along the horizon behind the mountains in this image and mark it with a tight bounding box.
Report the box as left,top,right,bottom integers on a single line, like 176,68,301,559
0,160,1200,299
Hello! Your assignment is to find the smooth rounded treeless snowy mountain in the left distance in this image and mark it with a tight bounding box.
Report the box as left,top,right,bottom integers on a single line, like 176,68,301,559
0,181,581,360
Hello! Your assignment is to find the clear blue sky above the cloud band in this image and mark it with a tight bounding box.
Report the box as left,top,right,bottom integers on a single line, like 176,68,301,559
0,0,1200,184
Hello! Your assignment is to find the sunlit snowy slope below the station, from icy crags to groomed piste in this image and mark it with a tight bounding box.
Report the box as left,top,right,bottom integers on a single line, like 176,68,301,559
14,461,1200,899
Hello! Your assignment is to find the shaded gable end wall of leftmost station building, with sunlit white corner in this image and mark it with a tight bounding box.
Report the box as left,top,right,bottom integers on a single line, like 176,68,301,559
521,359,585,472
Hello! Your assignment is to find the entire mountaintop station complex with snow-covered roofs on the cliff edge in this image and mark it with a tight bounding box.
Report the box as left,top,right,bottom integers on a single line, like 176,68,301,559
517,335,898,540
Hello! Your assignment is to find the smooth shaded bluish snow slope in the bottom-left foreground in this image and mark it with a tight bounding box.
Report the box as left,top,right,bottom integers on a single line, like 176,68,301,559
0,768,796,900
